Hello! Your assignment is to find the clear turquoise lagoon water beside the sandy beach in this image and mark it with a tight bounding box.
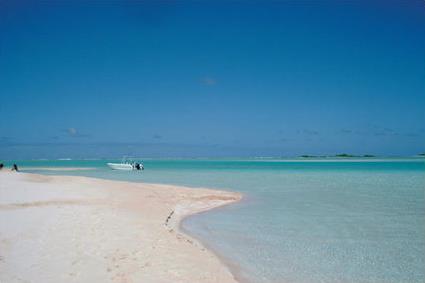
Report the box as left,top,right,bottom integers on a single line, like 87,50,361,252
9,159,425,283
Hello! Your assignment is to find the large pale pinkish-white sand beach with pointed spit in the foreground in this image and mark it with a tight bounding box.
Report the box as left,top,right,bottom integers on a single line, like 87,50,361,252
0,171,241,283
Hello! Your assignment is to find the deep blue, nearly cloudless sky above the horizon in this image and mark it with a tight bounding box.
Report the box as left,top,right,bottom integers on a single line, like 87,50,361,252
0,0,425,158
